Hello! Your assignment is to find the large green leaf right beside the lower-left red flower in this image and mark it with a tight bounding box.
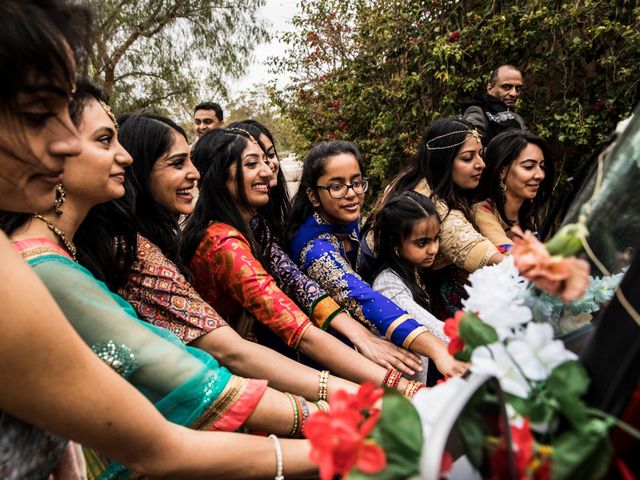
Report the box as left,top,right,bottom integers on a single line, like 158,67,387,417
347,390,423,480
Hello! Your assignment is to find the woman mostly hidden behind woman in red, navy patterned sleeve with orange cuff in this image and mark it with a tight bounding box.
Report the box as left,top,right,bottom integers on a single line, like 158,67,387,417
229,120,422,375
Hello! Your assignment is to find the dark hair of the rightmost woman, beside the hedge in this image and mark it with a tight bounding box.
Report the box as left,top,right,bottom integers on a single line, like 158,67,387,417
479,130,555,231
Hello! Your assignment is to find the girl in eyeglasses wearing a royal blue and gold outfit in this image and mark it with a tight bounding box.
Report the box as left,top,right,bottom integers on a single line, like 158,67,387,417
285,141,466,382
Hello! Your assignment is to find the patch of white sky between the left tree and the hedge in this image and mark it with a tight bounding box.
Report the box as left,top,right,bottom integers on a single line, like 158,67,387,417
229,0,298,97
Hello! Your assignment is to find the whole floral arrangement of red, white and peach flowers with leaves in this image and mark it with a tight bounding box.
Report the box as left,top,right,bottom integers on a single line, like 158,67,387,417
306,225,638,480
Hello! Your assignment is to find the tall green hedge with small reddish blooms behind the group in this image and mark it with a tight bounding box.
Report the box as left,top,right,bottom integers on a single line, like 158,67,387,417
273,0,640,206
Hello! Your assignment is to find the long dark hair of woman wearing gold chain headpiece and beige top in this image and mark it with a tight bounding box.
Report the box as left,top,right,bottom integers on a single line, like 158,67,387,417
380,118,474,223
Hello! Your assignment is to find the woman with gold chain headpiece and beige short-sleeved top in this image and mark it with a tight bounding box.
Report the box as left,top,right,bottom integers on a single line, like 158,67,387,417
360,118,504,319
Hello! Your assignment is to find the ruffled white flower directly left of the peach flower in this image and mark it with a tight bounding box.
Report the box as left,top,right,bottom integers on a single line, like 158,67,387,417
462,257,532,340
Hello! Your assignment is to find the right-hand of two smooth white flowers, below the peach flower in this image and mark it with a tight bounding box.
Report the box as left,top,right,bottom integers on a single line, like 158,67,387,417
507,322,578,381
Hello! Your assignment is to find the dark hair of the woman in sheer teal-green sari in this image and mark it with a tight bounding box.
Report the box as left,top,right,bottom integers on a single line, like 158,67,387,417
72,80,137,291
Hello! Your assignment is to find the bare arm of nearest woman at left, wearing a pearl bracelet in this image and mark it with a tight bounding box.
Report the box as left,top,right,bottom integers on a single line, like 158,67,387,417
0,235,315,478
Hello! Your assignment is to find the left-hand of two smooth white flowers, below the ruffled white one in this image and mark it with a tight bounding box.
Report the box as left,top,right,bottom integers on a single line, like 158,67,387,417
469,342,529,398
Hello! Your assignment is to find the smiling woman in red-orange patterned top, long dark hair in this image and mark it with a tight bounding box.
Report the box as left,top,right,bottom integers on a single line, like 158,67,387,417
182,128,418,389
